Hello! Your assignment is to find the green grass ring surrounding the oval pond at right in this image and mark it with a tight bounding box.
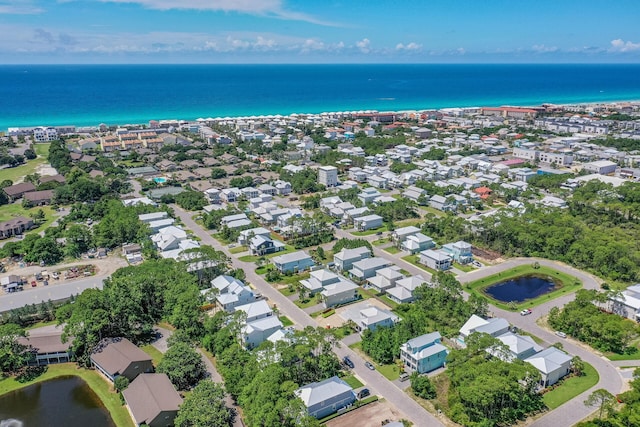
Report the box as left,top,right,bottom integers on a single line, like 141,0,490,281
464,264,582,311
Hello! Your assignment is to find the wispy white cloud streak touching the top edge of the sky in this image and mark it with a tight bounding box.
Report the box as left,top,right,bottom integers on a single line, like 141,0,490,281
100,0,341,27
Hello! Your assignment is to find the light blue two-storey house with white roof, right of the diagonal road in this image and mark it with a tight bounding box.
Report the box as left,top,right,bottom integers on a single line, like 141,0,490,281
400,332,448,374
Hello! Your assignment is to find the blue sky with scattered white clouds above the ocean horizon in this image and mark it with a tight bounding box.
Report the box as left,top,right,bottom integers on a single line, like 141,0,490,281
0,0,640,64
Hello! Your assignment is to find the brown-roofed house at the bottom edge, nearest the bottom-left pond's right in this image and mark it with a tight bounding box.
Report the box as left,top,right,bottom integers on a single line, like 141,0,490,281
122,374,182,427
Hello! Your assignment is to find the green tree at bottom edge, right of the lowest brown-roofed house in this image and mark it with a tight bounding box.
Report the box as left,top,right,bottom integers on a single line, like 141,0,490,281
174,380,233,427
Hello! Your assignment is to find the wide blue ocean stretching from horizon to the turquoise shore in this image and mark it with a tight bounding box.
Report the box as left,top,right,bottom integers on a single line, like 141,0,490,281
0,64,640,130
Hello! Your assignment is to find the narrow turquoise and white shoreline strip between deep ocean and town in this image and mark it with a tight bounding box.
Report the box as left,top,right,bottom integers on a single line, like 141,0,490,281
5,97,640,132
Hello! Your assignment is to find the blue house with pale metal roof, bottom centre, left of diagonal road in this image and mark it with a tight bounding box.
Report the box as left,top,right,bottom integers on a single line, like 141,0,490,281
294,376,356,419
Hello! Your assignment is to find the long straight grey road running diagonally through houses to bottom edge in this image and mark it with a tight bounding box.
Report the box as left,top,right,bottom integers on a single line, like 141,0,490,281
171,205,443,426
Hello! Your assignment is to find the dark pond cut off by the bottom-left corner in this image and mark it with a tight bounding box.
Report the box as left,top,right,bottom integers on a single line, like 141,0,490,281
0,376,115,427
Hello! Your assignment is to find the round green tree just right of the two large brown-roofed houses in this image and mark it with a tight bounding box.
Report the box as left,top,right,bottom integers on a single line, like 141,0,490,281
157,342,207,390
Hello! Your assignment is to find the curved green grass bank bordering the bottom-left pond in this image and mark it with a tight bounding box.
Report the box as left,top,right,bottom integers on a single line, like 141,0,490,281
0,363,133,427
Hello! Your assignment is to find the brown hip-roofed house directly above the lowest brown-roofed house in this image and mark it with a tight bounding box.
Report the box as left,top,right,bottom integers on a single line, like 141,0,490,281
90,338,153,382
